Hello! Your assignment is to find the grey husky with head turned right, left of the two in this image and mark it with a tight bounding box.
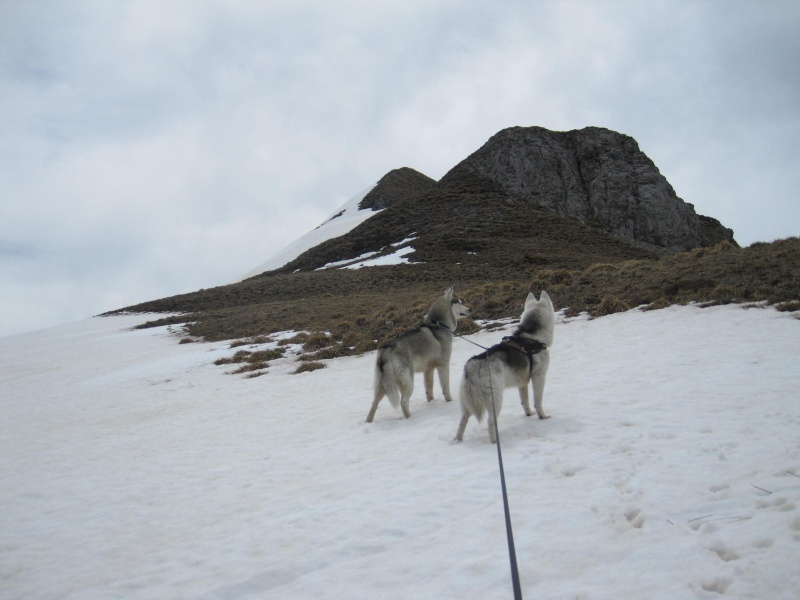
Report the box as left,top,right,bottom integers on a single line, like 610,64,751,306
367,287,470,423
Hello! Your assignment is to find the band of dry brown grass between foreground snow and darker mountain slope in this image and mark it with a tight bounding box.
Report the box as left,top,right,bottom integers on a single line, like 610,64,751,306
114,238,800,360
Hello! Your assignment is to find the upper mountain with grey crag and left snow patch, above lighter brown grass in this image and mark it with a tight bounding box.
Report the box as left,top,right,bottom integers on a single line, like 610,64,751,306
248,127,735,275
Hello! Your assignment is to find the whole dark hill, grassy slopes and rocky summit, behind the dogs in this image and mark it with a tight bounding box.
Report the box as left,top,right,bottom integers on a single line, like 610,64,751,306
103,128,800,353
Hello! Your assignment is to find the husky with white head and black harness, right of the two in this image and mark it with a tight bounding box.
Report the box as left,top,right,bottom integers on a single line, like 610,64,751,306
456,291,556,444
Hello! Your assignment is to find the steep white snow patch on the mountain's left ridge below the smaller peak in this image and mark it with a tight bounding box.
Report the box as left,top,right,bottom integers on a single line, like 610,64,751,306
238,185,380,281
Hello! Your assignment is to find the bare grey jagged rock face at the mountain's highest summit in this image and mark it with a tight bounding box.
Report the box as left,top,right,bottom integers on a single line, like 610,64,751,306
442,127,733,253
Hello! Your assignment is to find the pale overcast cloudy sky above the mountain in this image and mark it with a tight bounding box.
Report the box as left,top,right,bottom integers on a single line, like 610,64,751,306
0,0,800,335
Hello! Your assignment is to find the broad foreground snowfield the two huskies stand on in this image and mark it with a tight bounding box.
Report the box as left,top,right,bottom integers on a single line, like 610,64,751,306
0,306,800,600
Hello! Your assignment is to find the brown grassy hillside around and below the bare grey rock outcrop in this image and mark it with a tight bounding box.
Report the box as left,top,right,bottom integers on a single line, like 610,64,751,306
108,164,800,360
